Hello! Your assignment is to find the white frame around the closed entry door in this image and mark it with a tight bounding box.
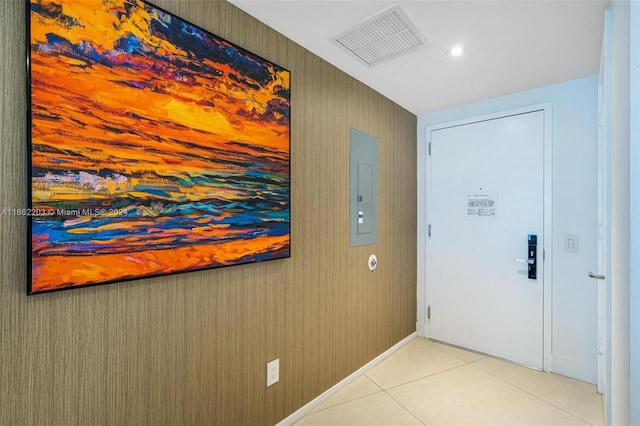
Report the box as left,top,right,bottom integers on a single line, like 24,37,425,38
417,102,553,371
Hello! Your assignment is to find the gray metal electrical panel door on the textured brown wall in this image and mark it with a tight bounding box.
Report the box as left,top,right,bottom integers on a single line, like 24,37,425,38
349,129,378,247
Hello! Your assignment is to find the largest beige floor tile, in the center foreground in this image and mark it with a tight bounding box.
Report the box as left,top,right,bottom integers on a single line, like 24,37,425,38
387,364,588,426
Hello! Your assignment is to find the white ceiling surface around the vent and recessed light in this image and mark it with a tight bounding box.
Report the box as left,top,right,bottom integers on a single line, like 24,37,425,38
229,0,609,115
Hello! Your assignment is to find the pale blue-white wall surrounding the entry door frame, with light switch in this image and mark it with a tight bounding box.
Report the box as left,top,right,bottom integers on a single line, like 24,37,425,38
417,76,598,383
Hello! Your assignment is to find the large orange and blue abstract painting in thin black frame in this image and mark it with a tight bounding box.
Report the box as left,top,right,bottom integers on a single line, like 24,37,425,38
22,0,290,294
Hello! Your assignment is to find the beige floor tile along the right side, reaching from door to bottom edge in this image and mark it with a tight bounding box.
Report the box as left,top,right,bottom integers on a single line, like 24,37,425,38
473,358,604,425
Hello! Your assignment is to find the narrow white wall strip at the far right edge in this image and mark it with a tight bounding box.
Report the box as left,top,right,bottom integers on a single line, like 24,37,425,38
606,0,640,425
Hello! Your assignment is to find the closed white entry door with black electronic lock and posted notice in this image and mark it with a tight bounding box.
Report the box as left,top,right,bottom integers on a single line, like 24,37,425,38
426,110,545,369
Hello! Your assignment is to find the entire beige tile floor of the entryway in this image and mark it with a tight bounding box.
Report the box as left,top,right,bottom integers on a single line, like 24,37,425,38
296,338,604,426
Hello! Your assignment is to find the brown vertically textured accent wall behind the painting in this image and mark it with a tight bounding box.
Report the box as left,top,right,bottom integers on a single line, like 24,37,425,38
0,0,416,425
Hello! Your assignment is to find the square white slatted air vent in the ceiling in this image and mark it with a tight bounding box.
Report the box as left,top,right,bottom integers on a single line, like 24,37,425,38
334,6,428,67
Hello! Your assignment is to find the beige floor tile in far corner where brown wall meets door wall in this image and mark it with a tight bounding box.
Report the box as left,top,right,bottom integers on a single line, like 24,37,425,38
367,338,465,389
